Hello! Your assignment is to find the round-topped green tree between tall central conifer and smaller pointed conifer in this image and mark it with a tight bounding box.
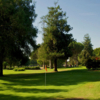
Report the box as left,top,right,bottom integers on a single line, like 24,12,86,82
69,41,84,66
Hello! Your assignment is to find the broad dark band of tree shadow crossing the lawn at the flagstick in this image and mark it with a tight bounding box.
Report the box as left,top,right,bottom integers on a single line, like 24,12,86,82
1,69,100,86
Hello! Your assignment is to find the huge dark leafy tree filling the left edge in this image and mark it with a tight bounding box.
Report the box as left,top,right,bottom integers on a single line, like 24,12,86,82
0,0,37,76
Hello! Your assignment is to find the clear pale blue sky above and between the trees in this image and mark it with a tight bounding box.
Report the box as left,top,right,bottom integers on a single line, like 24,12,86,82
33,0,100,49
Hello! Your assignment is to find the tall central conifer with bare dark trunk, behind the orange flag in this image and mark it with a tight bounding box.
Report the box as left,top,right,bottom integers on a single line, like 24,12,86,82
42,3,73,71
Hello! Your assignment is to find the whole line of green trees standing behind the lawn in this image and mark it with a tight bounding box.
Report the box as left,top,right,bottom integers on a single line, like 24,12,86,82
0,0,97,76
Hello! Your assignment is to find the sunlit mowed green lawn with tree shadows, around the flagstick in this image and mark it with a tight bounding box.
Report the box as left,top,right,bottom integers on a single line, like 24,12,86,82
0,67,100,100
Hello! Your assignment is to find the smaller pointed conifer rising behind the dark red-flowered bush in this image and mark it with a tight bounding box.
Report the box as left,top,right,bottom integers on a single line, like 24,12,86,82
78,34,93,65
